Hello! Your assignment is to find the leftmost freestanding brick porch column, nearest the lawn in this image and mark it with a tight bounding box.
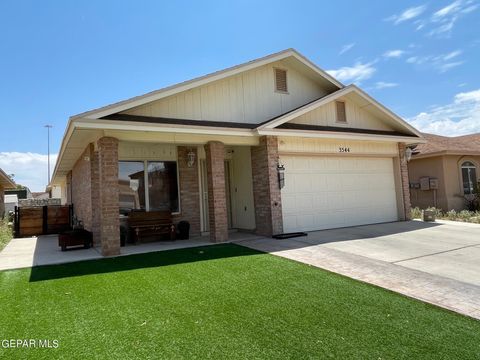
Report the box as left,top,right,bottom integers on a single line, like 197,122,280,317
97,137,120,256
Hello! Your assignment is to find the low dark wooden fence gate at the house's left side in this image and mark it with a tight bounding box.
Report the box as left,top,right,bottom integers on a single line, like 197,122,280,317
14,205,73,238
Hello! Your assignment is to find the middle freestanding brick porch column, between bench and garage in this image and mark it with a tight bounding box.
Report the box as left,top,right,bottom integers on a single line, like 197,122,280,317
205,141,228,242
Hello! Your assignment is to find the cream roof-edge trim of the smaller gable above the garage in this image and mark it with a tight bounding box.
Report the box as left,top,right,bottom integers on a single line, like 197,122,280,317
258,84,422,138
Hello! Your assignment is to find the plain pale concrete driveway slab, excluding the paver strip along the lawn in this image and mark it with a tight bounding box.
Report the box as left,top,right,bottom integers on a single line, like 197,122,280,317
303,221,480,286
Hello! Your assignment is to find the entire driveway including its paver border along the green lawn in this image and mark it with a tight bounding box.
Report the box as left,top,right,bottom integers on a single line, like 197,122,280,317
239,221,480,319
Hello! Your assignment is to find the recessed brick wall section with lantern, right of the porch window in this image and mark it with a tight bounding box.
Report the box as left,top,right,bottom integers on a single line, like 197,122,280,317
173,146,200,236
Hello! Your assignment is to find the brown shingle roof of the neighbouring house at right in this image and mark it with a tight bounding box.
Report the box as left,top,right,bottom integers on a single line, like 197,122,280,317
413,133,480,158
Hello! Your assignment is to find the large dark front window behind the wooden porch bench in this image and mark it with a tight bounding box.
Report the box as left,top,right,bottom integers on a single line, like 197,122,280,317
118,161,179,214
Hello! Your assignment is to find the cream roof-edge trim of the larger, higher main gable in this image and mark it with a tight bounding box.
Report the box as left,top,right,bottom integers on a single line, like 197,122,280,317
70,48,344,119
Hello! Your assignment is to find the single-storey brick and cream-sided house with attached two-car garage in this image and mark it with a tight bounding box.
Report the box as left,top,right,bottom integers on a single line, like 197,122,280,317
51,49,424,255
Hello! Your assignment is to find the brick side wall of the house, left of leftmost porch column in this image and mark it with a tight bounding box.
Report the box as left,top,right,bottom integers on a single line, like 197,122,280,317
71,144,93,231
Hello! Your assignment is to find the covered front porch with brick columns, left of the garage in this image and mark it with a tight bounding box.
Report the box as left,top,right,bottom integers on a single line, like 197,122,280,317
58,129,282,256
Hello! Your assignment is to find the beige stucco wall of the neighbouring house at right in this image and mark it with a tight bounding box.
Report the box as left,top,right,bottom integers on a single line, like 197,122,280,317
408,155,480,211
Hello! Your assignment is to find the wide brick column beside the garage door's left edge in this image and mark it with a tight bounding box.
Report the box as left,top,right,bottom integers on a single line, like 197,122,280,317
251,136,283,236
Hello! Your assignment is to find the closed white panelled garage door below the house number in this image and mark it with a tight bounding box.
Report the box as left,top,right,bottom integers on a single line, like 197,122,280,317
281,156,398,232
